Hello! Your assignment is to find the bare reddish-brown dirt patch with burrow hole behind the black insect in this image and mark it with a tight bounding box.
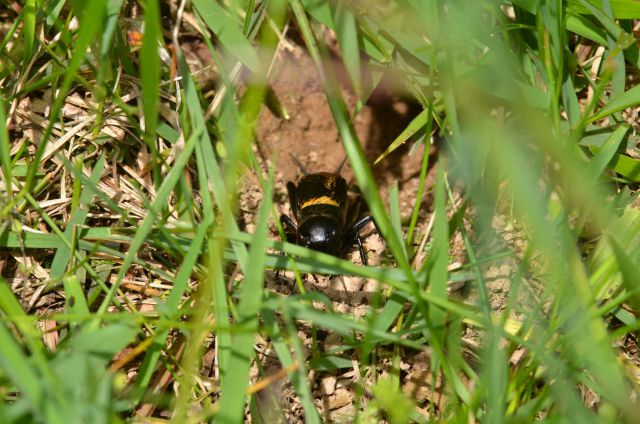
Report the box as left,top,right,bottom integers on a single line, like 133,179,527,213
246,37,435,255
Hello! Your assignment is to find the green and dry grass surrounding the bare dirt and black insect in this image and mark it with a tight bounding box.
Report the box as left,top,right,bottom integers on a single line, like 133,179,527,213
0,0,640,423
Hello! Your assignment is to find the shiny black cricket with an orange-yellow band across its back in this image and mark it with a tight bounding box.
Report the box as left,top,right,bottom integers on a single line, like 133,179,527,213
280,156,372,265
